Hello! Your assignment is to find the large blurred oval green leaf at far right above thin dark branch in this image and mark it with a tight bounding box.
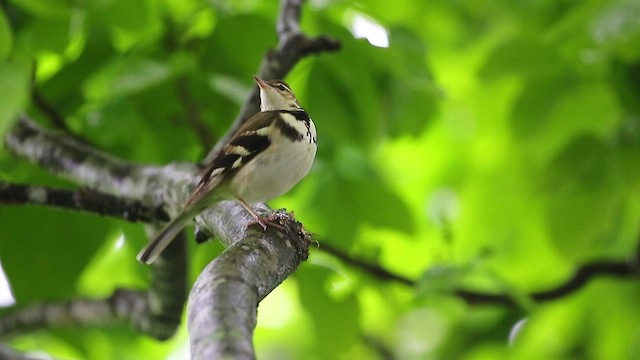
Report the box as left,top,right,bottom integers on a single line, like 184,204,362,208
542,136,625,259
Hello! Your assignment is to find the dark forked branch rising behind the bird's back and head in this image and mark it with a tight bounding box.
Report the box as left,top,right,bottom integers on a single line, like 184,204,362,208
202,0,340,164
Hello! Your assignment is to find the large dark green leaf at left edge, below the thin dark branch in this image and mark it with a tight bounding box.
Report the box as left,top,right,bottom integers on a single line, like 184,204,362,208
0,207,112,304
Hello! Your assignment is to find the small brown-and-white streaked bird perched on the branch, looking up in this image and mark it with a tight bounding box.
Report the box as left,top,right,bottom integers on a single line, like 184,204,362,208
138,76,317,264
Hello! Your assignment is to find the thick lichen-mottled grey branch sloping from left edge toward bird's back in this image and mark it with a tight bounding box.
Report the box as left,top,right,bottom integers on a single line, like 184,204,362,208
5,116,198,215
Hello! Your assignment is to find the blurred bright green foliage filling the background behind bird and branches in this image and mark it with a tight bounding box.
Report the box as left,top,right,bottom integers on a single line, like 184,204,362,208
0,0,640,359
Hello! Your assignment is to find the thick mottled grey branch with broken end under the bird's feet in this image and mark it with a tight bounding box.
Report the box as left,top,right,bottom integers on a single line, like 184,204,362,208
187,208,310,359
